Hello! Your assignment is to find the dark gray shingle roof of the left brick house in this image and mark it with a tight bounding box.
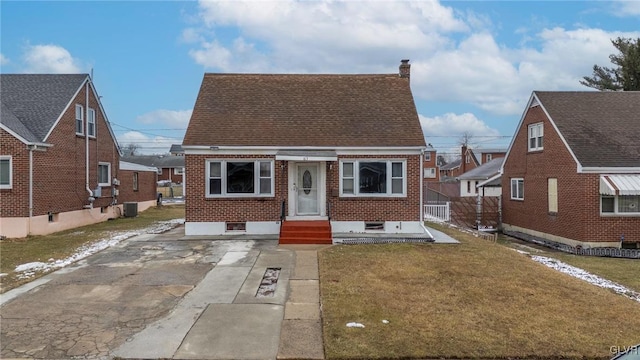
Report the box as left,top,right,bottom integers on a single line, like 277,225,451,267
0,74,88,142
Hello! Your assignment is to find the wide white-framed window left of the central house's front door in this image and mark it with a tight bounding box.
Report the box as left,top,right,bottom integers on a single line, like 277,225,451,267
206,160,274,197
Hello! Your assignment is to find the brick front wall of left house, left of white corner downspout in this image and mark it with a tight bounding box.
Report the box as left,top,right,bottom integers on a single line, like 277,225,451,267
0,129,29,217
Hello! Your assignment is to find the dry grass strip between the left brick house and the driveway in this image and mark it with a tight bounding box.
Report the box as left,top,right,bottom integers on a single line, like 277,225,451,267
0,205,184,293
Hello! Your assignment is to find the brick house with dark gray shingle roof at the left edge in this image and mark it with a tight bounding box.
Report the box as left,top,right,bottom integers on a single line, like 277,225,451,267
0,74,155,237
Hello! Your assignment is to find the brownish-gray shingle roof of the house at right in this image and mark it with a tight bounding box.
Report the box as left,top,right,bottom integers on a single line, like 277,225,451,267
534,91,640,167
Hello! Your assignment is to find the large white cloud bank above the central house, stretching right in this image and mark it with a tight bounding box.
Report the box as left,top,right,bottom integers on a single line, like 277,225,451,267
183,0,640,116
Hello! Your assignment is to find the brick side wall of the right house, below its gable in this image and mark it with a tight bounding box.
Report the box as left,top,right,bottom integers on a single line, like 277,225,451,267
502,106,640,242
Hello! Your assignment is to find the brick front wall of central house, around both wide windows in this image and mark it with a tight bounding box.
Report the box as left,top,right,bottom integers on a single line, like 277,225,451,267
185,154,422,222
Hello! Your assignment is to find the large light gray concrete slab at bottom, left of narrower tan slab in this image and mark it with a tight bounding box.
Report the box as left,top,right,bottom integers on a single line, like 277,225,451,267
173,304,284,360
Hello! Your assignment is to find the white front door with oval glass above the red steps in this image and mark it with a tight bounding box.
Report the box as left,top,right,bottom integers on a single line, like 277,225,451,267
293,163,323,216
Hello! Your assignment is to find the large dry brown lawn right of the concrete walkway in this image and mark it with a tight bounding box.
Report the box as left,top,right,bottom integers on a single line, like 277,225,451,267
319,224,640,359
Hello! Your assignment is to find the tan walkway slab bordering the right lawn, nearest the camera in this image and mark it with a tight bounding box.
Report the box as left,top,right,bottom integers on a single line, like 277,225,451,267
277,320,324,359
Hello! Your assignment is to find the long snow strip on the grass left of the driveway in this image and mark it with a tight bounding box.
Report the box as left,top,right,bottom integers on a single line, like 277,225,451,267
14,219,184,279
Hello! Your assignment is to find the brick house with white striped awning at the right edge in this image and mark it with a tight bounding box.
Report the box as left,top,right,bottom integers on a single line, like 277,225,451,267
502,91,640,247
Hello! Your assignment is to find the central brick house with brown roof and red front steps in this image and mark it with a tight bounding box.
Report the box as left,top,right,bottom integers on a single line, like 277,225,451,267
182,60,426,243
